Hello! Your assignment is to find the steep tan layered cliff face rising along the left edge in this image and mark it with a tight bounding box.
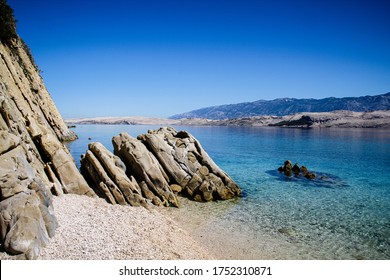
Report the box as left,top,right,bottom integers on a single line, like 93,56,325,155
0,39,94,258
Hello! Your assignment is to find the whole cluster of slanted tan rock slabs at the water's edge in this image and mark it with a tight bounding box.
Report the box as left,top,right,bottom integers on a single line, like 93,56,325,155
81,128,241,207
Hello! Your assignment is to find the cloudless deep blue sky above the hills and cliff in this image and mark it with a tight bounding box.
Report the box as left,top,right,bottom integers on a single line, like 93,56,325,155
8,0,390,118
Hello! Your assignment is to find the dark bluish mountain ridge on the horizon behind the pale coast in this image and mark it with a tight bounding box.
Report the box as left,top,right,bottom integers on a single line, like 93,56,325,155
170,92,390,120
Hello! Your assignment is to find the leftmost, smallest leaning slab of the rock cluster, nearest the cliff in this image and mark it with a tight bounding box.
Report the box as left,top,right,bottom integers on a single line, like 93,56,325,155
81,142,147,206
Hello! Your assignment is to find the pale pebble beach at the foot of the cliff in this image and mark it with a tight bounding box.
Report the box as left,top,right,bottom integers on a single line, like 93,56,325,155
0,194,214,260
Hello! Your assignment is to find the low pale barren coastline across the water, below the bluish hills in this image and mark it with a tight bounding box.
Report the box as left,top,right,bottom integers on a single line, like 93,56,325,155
65,110,390,128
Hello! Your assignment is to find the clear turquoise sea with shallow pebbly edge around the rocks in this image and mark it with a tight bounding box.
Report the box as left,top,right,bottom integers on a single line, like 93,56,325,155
67,125,390,260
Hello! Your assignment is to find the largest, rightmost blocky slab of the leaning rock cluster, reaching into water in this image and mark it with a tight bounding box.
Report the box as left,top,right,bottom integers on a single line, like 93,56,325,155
138,128,241,201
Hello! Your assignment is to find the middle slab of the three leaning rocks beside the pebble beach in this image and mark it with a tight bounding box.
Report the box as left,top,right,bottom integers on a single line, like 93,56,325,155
112,133,179,207
